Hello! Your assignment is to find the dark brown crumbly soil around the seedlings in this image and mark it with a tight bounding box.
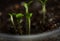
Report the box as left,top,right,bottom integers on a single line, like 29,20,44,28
0,0,60,34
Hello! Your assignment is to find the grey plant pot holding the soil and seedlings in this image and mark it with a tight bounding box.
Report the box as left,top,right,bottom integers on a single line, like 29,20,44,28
0,28,60,41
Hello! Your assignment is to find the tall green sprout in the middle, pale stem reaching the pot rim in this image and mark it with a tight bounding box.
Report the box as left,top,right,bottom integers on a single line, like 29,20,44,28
23,3,32,34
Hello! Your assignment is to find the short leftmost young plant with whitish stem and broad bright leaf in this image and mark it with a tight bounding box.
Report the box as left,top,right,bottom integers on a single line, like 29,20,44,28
9,13,24,35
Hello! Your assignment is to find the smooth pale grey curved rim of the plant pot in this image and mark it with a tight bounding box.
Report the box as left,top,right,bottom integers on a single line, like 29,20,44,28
0,28,60,40
